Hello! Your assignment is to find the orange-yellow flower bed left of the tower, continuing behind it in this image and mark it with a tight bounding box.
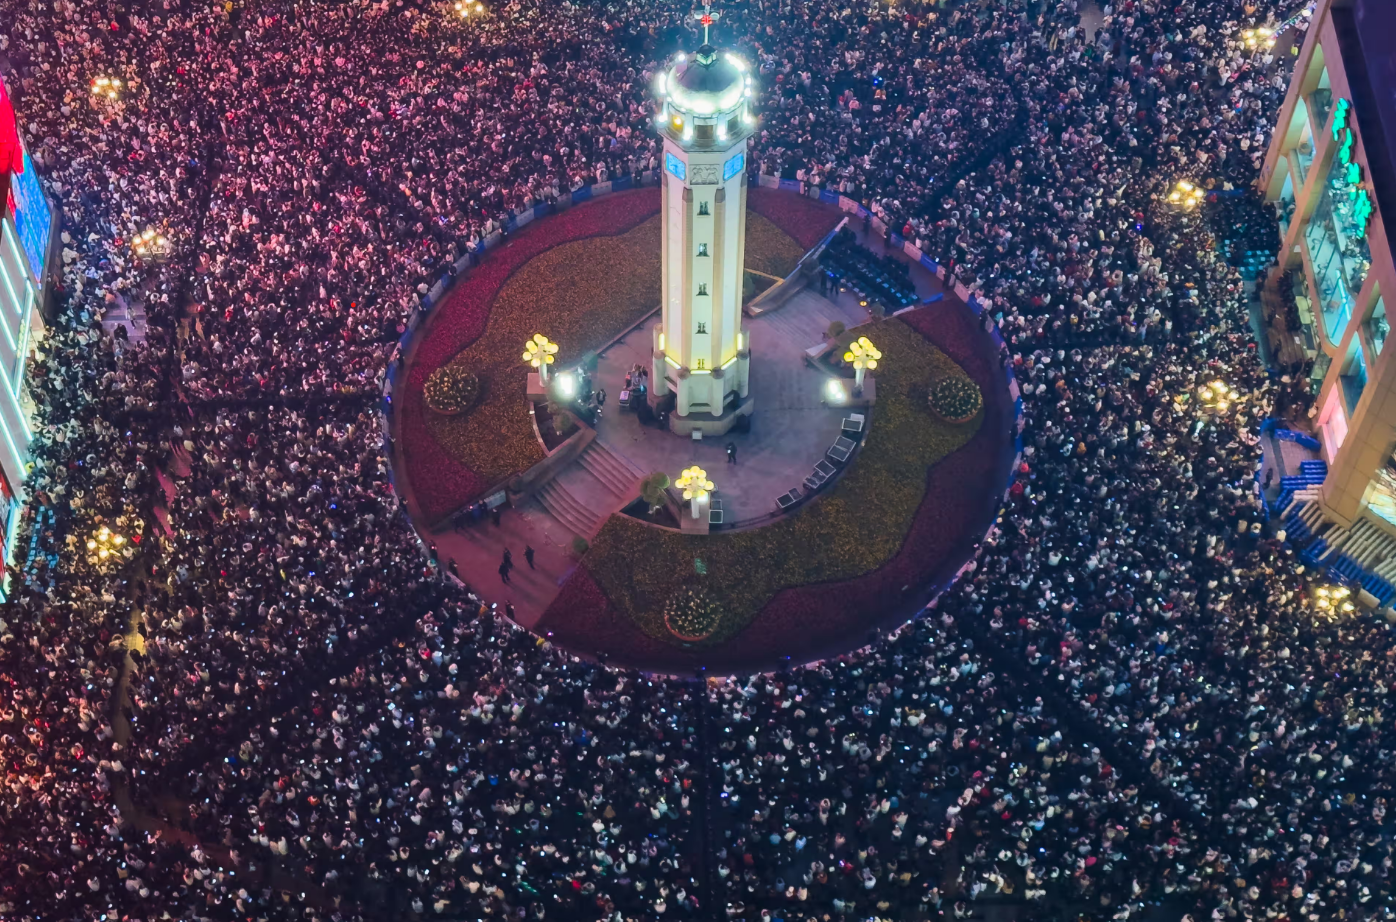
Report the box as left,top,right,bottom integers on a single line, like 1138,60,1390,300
427,212,804,483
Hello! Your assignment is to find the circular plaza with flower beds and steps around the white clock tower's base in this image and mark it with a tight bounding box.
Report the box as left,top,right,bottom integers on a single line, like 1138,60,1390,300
389,187,1012,675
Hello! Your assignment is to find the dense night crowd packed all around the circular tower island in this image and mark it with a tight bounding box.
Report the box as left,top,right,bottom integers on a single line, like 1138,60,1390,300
0,0,1396,922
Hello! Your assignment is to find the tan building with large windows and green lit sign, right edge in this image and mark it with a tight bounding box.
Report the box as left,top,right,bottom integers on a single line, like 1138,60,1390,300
1259,0,1396,535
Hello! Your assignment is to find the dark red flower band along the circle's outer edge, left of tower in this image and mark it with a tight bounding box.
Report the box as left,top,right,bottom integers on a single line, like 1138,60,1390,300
394,189,659,521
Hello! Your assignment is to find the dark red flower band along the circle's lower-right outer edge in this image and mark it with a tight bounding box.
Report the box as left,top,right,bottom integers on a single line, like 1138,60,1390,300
537,298,1013,675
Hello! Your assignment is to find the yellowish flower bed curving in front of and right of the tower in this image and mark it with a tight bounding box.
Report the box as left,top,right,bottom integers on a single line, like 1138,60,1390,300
585,312,983,643
